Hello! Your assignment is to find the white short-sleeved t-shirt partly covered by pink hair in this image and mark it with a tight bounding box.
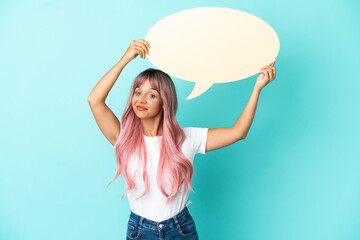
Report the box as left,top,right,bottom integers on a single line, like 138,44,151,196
113,127,208,222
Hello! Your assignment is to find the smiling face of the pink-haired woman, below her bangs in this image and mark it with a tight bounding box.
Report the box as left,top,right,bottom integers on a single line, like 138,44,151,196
132,79,163,118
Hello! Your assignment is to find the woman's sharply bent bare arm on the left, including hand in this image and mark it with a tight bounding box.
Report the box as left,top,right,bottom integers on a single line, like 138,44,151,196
88,40,149,146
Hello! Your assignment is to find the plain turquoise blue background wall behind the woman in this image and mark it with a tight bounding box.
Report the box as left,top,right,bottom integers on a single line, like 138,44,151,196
0,0,360,240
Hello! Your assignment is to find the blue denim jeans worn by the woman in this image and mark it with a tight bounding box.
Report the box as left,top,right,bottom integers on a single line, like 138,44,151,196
126,207,199,240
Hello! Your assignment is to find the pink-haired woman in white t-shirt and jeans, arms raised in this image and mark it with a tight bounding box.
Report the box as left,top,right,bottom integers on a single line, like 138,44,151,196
88,40,276,239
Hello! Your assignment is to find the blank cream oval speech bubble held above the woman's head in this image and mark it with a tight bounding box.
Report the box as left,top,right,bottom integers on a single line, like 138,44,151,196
145,7,280,100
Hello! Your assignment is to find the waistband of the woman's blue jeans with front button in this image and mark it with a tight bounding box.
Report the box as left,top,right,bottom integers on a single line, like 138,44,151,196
130,207,190,230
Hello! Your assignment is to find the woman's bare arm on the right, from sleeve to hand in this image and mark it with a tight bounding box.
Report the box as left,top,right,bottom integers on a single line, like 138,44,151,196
205,59,276,152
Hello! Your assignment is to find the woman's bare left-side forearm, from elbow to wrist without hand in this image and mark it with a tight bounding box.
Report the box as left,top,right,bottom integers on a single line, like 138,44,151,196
88,58,129,103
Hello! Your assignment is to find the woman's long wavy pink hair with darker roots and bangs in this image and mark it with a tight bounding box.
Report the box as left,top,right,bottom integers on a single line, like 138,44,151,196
108,68,194,204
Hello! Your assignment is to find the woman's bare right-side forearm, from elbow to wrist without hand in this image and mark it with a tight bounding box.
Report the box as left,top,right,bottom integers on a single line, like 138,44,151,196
233,87,261,139
